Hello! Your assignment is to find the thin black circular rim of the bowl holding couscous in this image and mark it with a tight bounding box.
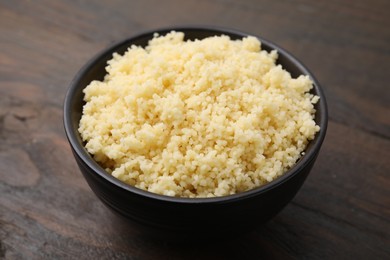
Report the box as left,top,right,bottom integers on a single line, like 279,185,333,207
63,26,328,204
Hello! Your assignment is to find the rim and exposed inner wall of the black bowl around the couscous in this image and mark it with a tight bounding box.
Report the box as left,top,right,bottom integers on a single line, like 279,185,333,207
64,28,327,202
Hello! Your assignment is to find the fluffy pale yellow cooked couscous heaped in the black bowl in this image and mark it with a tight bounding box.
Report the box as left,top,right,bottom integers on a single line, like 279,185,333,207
79,31,320,198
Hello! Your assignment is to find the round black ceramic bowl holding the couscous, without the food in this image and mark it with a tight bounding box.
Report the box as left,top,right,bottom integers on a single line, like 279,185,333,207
64,28,328,238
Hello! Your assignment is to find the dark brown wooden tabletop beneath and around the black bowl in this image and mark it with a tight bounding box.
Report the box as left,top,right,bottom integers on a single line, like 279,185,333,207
0,0,390,259
